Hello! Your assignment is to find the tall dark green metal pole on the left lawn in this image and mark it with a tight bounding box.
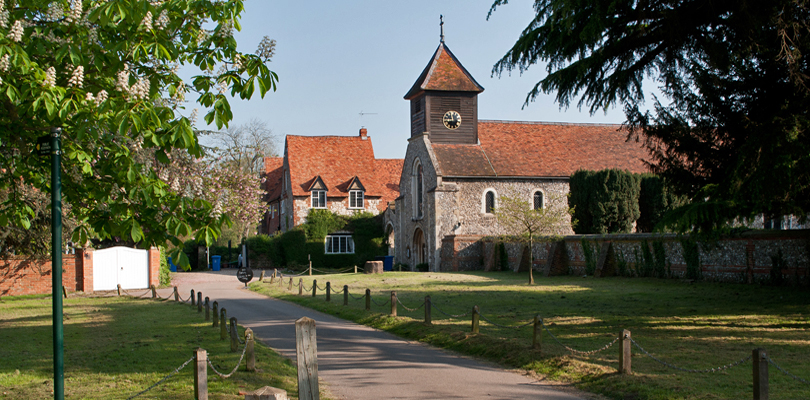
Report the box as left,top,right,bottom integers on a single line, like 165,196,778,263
51,127,65,400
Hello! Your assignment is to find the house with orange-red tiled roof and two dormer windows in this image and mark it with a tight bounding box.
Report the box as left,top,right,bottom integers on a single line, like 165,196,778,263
264,128,402,238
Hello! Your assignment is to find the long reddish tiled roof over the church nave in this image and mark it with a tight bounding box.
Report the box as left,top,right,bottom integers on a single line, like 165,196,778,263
432,121,649,177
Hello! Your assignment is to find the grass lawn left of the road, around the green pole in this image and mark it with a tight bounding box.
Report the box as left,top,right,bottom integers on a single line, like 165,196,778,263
0,296,298,400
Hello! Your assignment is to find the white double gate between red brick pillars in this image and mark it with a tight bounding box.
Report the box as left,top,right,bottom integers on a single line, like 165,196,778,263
93,247,149,290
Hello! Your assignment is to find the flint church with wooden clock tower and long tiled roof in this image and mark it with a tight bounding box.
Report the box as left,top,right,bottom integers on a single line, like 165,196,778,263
385,41,648,271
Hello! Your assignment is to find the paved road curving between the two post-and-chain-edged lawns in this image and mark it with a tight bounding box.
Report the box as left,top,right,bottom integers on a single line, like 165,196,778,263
161,270,596,400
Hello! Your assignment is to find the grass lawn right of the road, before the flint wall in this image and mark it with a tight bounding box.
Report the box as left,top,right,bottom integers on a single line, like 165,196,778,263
251,272,810,400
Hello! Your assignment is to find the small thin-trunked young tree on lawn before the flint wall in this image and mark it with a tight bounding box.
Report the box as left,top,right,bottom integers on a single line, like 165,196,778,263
494,191,576,285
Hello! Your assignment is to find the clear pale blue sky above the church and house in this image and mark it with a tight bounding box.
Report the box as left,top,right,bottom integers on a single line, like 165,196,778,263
199,0,636,158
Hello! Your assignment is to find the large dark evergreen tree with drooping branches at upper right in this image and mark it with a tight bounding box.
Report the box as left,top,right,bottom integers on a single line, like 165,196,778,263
490,0,810,230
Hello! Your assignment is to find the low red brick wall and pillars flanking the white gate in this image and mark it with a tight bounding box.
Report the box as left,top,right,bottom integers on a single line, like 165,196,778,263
0,247,160,297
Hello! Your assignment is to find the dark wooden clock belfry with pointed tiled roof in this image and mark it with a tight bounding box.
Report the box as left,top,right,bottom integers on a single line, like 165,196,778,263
405,34,484,144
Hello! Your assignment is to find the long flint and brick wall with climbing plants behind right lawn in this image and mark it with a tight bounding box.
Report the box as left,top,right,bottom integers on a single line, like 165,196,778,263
440,230,810,283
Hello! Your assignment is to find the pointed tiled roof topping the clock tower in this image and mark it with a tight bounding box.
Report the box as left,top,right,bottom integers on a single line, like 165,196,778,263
405,41,484,100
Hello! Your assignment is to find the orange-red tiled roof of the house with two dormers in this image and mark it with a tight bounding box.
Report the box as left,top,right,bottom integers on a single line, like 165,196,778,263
286,135,402,205
